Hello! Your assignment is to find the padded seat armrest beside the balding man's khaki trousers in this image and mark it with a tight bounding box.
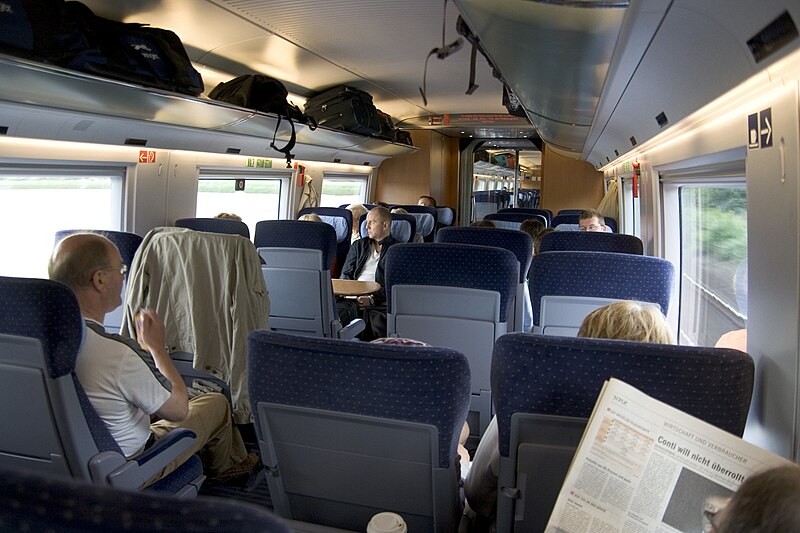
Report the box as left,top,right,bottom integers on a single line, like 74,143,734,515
99,429,197,490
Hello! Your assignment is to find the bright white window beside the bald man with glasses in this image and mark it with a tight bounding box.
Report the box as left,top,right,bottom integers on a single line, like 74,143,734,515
0,166,125,278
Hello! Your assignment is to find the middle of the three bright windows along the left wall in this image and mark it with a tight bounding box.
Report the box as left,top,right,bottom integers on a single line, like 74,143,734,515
196,170,292,230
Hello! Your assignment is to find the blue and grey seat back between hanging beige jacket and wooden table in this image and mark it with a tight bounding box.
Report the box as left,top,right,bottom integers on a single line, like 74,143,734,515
255,219,349,337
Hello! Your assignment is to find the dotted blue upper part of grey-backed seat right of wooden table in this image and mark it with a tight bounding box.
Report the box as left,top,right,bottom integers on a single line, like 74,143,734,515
386,244,519,322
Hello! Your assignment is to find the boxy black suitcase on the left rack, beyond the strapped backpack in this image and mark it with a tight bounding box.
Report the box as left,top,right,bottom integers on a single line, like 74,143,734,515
305,85,381,135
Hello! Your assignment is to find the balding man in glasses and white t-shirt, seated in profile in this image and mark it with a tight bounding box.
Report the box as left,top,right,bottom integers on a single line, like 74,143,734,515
48,233,258,486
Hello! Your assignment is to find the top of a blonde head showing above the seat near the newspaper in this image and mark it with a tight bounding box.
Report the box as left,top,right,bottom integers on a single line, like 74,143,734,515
578,300,675,344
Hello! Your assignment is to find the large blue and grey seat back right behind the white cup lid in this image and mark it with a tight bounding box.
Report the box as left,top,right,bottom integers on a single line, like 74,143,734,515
248,330,470,532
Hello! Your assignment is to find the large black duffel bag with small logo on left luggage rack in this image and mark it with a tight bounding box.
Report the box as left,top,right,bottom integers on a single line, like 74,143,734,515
57,2,203,96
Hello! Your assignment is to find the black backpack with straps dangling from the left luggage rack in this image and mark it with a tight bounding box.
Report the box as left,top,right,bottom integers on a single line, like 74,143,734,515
208,74,317,168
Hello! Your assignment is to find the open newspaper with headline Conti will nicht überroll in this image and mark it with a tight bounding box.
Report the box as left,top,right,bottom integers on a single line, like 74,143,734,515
546,379,789,533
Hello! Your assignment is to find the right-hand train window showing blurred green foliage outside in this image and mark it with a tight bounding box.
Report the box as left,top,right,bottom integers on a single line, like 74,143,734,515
678,183,747,346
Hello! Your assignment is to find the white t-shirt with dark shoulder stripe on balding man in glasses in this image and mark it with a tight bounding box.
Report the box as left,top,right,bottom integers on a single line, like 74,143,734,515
75,319,170,457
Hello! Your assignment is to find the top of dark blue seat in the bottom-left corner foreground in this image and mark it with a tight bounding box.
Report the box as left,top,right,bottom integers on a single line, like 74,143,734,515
0,468,289,533
